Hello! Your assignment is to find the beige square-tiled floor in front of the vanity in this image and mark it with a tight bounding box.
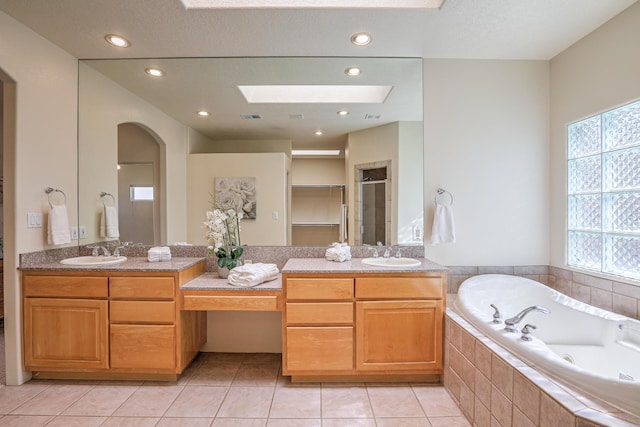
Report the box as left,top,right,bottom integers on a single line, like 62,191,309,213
0,330,469,427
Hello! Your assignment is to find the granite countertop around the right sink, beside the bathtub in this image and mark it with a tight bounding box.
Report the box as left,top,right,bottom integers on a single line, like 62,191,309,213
282,258,447,273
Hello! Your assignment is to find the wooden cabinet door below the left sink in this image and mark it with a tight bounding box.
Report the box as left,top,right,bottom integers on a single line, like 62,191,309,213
24,298,109,370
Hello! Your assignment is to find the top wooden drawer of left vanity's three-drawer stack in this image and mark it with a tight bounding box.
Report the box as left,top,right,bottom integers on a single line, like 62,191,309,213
109,277,175,299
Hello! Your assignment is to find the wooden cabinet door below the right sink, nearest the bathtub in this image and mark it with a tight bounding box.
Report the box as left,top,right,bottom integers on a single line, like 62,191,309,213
356,300,443,372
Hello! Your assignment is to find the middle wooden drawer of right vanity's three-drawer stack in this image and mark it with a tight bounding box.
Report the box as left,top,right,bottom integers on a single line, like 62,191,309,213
286,302,353,325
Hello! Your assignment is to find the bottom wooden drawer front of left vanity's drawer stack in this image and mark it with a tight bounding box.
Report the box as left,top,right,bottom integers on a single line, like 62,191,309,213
111,324,176,370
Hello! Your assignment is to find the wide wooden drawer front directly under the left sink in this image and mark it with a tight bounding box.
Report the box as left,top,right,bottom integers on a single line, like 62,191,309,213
22,275,109,298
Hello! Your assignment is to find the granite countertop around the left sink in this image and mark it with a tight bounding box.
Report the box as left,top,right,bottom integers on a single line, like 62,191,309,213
20,257,206,272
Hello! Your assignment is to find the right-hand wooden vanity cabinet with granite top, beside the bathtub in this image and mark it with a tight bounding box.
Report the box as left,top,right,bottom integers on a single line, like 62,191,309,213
282,259,446,382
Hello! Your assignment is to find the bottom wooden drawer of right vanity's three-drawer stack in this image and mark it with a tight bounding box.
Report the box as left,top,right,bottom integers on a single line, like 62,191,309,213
286,326,353,371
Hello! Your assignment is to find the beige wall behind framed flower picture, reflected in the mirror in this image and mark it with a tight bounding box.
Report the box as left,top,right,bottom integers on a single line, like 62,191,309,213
186,153,289,246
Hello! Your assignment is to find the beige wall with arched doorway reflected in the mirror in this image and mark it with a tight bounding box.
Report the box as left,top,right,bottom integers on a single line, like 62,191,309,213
78,63,187,243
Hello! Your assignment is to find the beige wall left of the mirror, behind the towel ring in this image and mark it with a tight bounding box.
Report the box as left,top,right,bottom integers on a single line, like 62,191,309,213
0,12,78,384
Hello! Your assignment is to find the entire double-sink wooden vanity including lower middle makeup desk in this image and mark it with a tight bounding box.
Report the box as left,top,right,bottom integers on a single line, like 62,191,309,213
21,258,446,382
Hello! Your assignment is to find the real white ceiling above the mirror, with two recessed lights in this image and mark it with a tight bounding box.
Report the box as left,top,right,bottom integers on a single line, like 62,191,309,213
0,0,635,60
